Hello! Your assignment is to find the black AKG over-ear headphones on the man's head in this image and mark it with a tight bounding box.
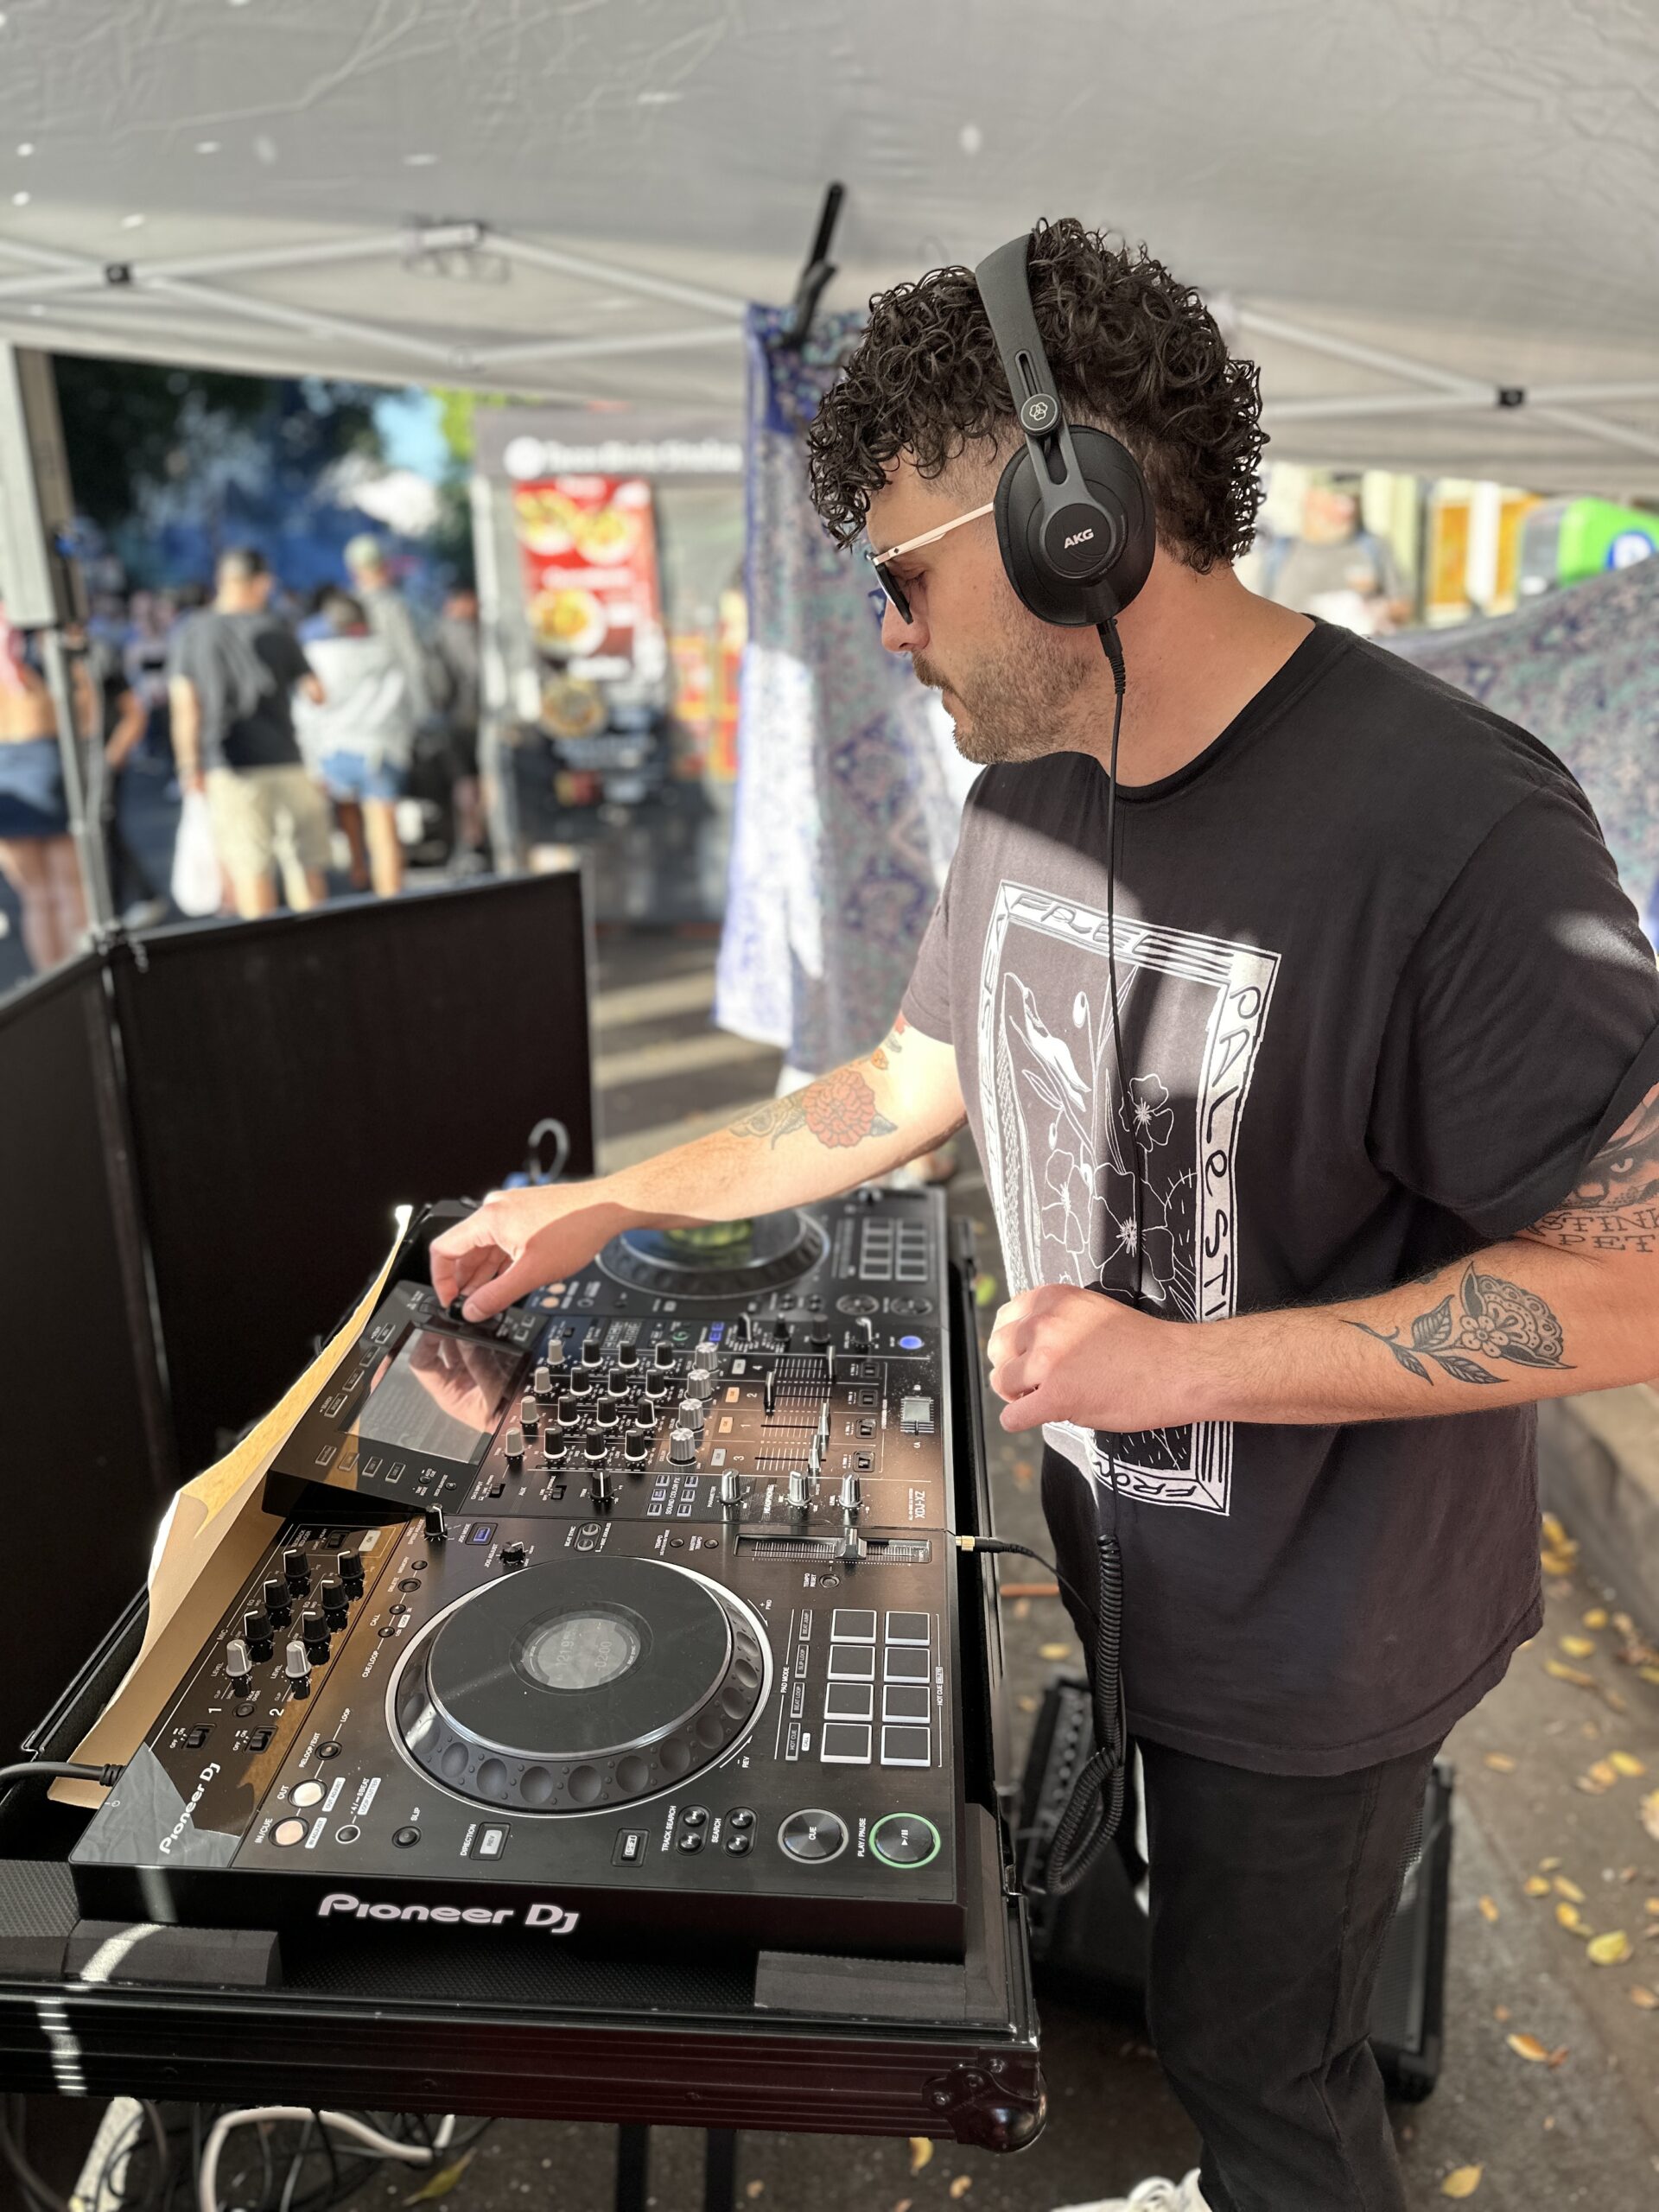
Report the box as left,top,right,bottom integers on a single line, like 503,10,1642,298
973,237,1157,631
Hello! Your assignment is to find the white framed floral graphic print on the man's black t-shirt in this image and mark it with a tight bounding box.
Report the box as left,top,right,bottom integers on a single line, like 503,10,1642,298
978,882,1279,1513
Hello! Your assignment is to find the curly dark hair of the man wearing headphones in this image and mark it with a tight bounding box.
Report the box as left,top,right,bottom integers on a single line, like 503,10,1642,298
807,217,1268,575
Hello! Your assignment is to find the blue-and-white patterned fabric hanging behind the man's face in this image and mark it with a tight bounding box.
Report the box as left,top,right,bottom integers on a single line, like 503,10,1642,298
715,308,960,1075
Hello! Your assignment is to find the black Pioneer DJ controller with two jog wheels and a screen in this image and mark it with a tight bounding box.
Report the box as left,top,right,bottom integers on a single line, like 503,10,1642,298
73,1190,964,1955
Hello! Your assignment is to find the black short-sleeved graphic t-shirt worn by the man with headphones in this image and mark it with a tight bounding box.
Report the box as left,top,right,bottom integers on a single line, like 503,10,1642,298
905,624,1659,1774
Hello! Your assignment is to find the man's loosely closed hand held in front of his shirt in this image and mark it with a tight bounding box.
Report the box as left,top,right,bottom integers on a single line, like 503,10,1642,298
987,1283,1204,1435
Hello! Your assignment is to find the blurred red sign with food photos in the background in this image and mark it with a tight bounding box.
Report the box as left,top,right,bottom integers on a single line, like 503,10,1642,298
513,475,661,677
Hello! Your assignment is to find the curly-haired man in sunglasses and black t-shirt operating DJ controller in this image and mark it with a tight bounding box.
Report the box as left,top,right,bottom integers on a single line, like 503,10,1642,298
434,221,1659,2212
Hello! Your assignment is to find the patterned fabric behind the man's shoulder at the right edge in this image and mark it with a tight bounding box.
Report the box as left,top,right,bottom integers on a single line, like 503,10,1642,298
1389,560,1659,938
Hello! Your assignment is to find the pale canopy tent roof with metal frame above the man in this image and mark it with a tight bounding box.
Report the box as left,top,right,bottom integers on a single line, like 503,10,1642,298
0,0,1659,493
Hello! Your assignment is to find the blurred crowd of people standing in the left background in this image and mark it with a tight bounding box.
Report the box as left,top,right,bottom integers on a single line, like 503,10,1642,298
0,536,489,971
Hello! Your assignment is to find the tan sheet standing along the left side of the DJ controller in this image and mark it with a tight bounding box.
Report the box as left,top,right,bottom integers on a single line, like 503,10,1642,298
51,1228,403,1808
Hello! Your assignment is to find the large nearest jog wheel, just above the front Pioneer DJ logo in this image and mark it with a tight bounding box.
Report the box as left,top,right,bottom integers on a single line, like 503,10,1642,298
390,1557,772,1814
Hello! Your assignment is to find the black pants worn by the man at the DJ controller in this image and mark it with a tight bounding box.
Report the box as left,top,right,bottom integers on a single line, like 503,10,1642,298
1141,1743,1435,2212
